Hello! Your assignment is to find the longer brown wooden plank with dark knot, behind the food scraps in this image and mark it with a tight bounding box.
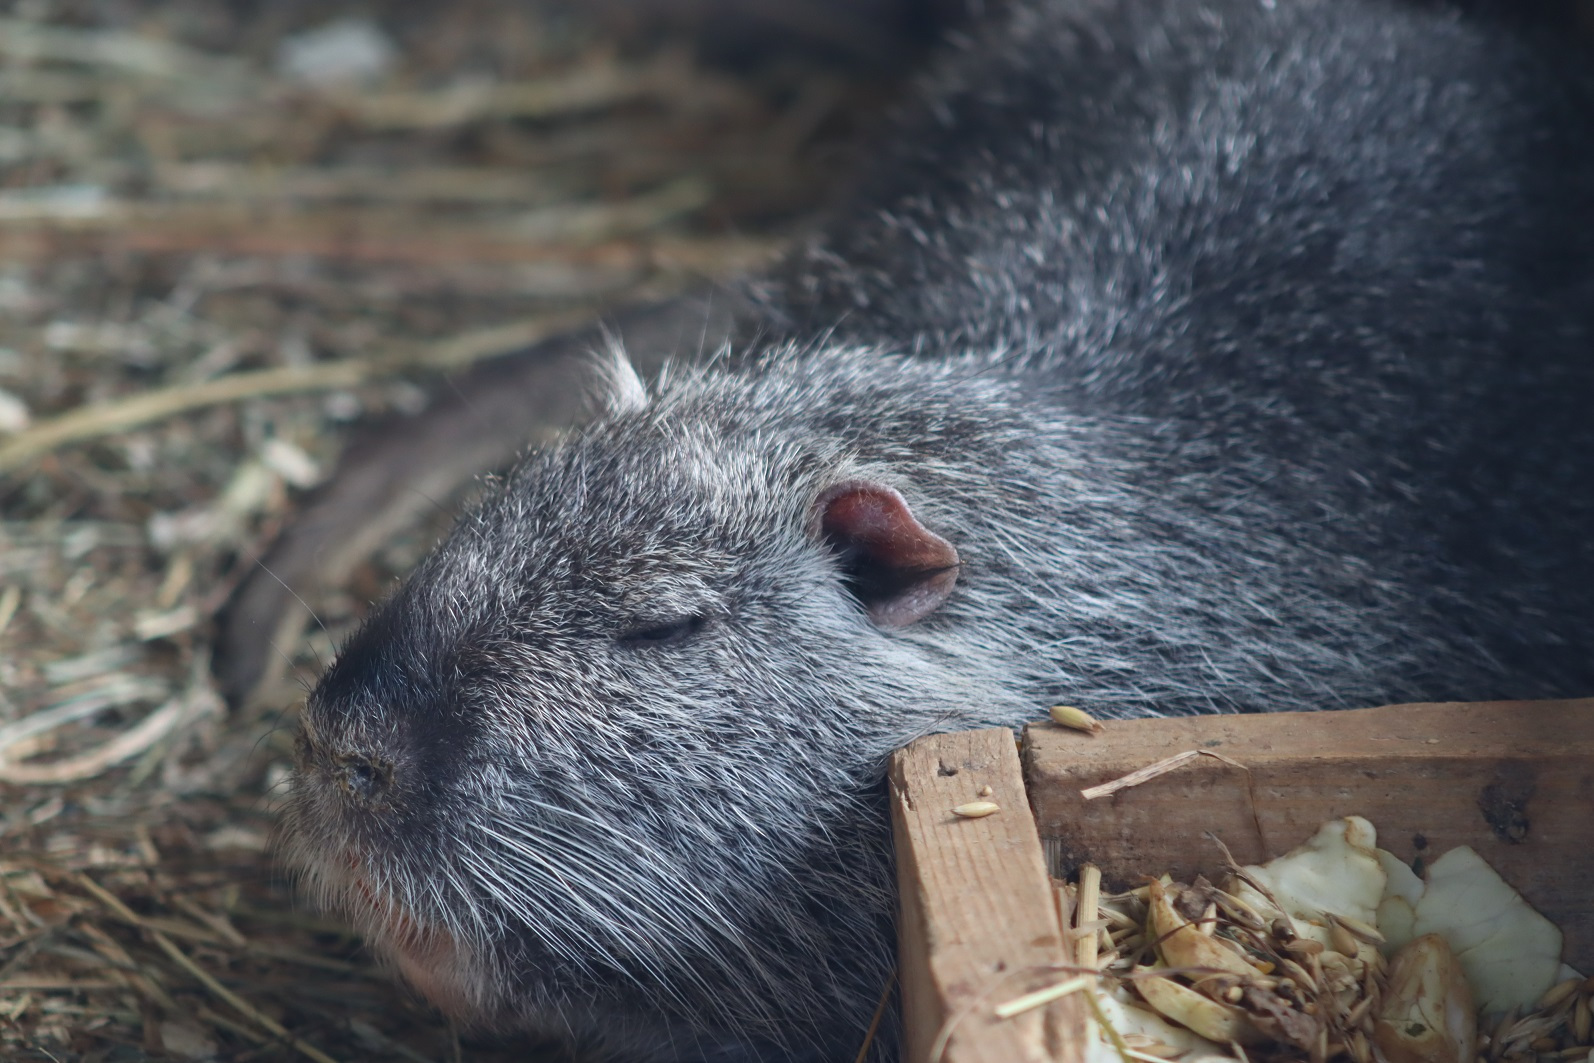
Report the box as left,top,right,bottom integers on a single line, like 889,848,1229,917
1025,700,1594,971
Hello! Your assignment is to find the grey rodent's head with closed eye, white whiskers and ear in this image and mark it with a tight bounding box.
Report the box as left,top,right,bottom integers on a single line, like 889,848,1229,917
287,350,964,1058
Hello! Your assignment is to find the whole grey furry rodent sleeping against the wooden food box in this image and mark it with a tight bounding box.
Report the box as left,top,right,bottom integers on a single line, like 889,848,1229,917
289,0,1594,1061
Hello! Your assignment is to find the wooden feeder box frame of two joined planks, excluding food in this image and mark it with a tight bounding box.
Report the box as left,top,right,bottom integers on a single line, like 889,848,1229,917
891,700,1594,1063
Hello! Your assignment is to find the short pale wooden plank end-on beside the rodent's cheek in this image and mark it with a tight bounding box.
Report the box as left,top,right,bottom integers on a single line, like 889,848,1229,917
891,728,1086,1063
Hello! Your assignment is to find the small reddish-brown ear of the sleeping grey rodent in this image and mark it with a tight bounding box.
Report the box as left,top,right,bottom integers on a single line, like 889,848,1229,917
815,480,958,628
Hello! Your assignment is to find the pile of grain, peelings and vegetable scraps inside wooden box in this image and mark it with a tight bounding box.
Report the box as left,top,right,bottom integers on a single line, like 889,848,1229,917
1066,816,1594,1063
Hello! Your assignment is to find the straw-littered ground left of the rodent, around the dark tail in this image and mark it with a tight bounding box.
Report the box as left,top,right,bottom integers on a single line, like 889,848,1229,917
0,0,875,1063
